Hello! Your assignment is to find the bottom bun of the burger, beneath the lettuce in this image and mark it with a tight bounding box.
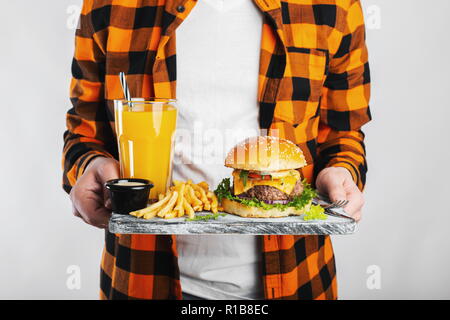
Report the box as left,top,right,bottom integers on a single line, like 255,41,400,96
222,198,311,218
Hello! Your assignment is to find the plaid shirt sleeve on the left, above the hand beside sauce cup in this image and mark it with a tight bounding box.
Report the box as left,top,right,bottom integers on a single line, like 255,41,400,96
63,0,114,192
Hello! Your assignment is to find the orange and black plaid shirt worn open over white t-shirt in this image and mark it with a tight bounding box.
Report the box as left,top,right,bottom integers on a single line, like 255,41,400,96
63,0,371,299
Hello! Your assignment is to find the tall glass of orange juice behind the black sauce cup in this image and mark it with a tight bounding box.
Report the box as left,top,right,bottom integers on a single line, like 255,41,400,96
114,98,177,199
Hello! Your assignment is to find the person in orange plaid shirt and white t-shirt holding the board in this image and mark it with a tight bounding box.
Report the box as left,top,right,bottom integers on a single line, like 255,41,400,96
64,0,370,299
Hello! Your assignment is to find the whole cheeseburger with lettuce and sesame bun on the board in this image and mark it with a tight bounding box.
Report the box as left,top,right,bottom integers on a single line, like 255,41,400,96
215,136,316,218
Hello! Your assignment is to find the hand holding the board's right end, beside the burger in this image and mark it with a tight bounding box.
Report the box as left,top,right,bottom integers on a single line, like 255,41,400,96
316,167,364,221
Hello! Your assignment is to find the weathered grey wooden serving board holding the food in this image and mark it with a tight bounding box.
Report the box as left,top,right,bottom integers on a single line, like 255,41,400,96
109,209,356,235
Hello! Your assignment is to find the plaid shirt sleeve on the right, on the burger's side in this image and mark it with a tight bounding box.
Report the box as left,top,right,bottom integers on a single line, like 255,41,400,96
317,0,371,189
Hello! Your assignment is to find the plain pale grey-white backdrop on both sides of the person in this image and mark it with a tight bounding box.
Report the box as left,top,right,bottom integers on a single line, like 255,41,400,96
0,0,450,299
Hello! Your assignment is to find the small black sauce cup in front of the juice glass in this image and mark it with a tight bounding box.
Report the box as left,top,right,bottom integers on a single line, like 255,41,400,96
105,178,153,214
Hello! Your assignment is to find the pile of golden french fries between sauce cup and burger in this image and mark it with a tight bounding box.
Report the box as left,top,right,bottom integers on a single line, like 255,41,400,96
130,180,221,219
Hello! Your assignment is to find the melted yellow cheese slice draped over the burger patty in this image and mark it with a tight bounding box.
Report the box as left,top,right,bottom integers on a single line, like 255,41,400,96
233,170,300,196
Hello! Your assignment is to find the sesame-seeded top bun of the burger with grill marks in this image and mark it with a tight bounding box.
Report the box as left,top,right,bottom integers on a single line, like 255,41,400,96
225,136,306,171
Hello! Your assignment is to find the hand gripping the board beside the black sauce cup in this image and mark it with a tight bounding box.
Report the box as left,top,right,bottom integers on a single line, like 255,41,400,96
70,157,119,229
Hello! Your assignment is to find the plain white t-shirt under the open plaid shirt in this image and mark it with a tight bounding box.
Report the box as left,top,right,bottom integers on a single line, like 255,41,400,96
173,0,263,299
